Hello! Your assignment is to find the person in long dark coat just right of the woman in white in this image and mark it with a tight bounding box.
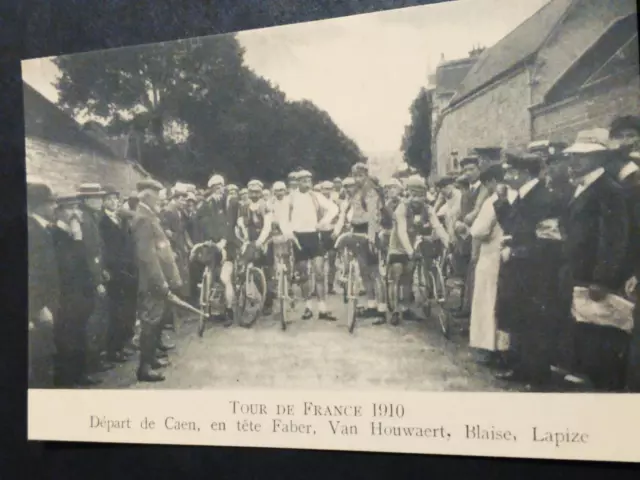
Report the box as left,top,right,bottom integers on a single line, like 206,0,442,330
494,154,568,384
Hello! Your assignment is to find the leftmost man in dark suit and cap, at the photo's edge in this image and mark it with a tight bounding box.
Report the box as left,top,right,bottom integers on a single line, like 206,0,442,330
27,182,60,388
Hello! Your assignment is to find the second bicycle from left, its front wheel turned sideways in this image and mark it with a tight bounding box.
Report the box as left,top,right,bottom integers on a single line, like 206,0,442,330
233,242,267,328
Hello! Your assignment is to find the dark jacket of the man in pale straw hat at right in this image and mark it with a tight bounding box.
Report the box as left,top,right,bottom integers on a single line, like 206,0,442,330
562,174,629,290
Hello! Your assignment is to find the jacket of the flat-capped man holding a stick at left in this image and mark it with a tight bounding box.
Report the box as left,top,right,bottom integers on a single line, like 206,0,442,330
131,202,182,296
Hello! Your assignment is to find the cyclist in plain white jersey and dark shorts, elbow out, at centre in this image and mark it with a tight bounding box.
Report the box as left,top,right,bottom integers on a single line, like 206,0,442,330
287,171,338,321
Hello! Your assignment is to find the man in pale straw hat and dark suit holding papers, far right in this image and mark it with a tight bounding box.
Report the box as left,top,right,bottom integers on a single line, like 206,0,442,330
562,131,630,391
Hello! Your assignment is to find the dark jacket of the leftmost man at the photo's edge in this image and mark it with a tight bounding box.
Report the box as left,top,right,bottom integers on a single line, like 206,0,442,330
27,217,60,321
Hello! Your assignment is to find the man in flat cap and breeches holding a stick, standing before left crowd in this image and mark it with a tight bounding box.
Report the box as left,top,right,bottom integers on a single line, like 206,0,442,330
131,180,182,382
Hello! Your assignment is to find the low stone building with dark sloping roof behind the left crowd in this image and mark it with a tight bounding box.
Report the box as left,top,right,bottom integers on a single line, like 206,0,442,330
23,83,154,195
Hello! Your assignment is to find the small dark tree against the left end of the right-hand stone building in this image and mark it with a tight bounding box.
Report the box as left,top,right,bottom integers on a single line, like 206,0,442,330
400,87,433,177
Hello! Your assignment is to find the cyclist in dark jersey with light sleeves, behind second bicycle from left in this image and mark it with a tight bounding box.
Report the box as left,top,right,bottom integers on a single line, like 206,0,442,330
238,180,273,318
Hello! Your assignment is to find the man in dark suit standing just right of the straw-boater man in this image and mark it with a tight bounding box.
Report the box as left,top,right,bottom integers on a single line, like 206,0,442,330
99,185,138,363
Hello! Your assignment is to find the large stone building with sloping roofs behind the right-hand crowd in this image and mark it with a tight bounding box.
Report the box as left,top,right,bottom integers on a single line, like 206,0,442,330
434,0,640,174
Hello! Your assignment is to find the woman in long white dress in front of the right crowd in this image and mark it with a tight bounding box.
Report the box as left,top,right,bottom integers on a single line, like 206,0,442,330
469,164,517,360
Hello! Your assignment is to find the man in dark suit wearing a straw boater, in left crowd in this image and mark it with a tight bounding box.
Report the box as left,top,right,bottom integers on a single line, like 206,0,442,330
76,183,113,372
